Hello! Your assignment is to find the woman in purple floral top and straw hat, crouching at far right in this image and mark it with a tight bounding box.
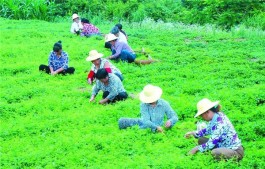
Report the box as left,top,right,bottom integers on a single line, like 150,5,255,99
185,98,244,160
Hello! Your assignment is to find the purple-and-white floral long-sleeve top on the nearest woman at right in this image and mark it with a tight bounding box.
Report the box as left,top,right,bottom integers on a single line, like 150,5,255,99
195,112,241,152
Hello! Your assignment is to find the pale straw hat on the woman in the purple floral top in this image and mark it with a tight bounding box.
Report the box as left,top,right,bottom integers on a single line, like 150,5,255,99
194,98,220,118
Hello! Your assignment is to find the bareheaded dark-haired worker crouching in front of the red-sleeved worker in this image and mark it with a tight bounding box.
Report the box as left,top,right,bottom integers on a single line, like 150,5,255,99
89,68,128,104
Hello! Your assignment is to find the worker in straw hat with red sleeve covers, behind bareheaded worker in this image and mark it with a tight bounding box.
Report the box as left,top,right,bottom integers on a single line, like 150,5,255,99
86,50,123,84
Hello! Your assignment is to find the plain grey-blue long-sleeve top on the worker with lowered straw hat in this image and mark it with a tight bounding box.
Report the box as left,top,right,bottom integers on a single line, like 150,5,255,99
140,99,178,131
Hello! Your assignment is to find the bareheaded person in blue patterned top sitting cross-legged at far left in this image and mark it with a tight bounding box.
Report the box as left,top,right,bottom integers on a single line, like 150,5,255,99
39,41,75,75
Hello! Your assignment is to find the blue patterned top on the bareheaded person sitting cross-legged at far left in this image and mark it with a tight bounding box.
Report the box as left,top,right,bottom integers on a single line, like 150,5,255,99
48,51,68,71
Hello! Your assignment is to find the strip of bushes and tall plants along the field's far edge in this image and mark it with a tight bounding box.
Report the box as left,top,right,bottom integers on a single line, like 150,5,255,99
0,0,265,30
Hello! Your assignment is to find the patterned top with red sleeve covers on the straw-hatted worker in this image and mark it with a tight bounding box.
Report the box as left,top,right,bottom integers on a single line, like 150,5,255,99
87,58,122,80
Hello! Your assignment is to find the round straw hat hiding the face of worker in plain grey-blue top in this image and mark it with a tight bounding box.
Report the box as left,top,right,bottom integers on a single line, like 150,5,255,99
139,84,162,103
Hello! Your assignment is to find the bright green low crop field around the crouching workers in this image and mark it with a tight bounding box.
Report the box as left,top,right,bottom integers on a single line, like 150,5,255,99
0,18,265,169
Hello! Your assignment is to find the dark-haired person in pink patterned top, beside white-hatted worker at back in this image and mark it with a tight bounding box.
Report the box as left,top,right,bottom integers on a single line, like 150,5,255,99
80,18,100,37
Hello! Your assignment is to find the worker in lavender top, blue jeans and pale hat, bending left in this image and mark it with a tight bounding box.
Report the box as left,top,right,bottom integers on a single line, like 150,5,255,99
105,33,156,64
